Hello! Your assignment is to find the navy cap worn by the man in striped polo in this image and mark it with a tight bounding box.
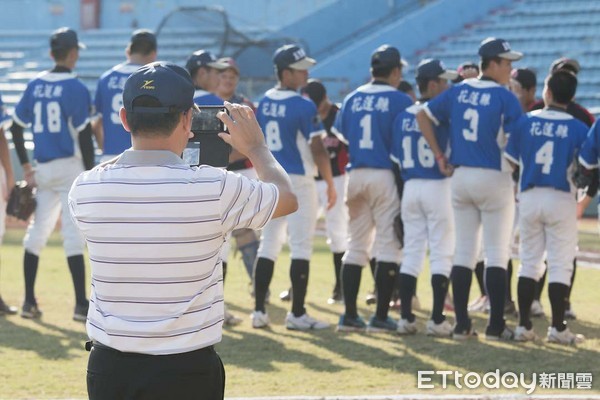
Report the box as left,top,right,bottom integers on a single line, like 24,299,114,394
123,61,195,114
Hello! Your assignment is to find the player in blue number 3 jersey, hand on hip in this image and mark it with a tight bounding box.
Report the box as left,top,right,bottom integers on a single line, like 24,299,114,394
417,38,523,340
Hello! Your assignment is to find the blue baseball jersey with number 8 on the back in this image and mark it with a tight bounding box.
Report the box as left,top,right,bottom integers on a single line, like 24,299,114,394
256,89,324,176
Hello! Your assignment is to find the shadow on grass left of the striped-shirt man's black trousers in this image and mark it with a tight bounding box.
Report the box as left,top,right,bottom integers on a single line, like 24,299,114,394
0,317,86,360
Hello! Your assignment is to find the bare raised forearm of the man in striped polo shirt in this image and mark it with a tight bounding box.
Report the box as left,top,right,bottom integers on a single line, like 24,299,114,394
247,146,298,218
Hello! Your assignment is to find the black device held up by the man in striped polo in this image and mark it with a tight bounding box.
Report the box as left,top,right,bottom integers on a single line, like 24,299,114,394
181,106,231,168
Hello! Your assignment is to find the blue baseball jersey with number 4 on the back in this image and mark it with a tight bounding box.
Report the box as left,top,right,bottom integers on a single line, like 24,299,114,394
504,109,588,192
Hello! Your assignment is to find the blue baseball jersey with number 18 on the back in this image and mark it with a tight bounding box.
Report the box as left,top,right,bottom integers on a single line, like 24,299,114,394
13,72,92,162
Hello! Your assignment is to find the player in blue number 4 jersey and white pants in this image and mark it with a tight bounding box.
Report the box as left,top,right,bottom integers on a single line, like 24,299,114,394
504,71,588,344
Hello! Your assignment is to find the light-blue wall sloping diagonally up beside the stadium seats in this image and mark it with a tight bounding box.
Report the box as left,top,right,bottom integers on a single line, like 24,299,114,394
311,0,512,92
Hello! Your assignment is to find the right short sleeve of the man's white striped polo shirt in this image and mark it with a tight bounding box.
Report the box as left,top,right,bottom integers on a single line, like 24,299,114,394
221,171,279,234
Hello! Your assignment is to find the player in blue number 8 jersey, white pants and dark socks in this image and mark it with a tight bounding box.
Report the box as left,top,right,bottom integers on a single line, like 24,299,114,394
252,45,336,330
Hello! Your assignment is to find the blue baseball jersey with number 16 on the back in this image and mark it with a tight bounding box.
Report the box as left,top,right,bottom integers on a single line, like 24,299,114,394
390,104,448,182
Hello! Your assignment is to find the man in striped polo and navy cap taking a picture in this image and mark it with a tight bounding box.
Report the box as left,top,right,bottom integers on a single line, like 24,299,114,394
69,62,297,399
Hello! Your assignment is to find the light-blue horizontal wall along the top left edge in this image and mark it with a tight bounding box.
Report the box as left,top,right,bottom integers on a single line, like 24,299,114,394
0,0,336,30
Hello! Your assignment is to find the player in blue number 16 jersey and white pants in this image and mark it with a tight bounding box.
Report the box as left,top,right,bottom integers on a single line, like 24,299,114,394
390,59,458,337
